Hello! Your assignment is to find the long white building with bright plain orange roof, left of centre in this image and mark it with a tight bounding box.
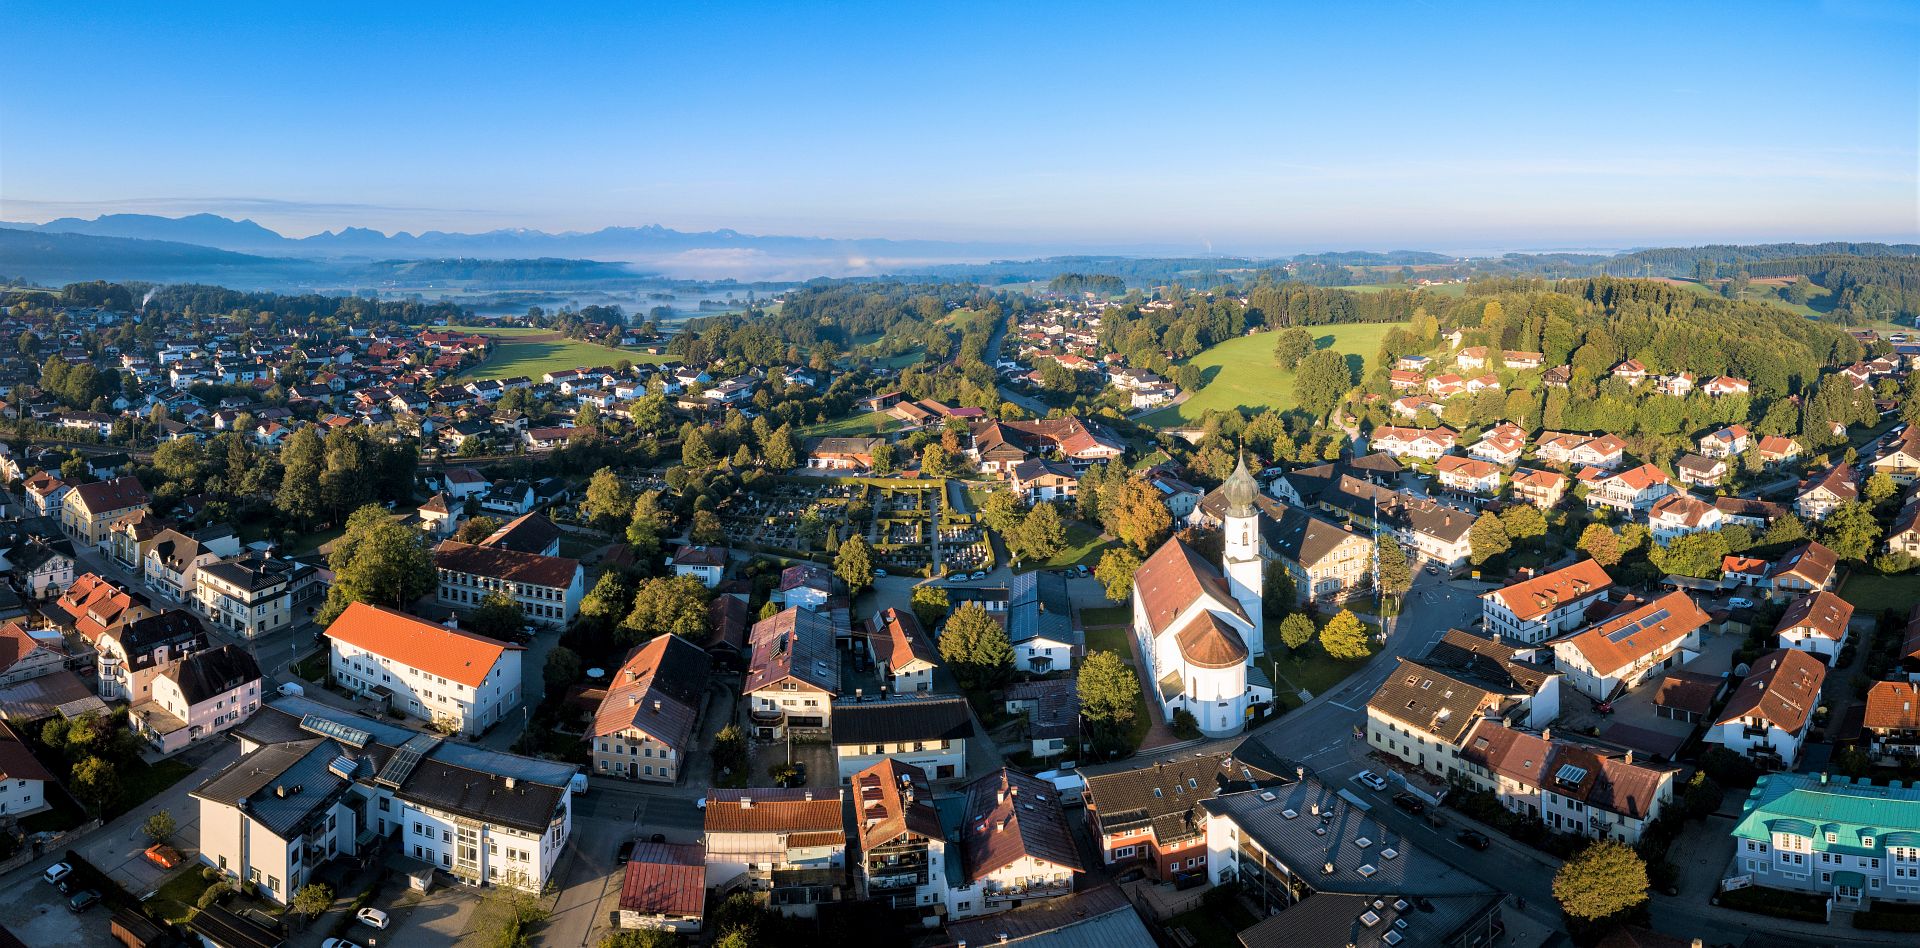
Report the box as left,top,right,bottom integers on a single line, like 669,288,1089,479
326,603,526,737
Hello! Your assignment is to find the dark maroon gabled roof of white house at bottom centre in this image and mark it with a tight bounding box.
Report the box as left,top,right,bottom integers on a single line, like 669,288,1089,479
960,768,1081,881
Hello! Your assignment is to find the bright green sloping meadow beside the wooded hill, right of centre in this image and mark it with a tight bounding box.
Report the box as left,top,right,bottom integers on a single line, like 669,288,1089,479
1140,322,1405,428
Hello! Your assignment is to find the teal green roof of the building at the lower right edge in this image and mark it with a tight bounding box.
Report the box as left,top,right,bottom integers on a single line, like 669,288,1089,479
1734,773,1920,856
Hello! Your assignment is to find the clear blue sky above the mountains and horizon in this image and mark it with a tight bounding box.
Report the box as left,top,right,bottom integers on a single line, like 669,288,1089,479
0,0,1920,251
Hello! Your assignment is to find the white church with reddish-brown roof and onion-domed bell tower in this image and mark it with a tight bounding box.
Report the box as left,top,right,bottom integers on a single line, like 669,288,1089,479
1133,457,1273,737
